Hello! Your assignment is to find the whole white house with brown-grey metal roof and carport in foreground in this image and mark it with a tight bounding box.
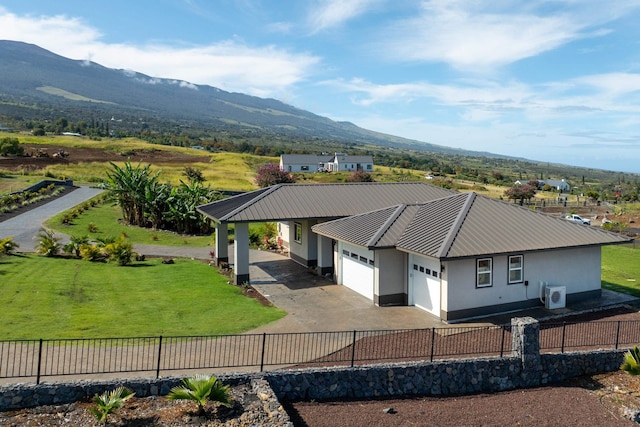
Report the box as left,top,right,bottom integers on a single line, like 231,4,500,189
198,182,631,321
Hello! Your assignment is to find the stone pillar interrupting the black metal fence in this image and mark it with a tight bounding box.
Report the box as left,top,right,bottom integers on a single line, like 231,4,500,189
511,317,542,387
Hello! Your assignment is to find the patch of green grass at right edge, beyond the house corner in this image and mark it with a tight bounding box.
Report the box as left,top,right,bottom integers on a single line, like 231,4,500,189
602,245,640,297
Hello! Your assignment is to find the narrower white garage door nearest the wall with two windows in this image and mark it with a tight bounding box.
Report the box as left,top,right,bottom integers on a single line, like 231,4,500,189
411,257,440,316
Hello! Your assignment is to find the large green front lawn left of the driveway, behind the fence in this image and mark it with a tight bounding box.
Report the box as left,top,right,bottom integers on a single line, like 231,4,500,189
0,255,285,340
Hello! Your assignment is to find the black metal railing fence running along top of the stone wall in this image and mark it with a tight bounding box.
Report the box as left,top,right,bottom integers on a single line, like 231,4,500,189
0,321,640,383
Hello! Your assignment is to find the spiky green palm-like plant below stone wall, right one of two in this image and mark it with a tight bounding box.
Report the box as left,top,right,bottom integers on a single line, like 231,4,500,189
167,374,232,414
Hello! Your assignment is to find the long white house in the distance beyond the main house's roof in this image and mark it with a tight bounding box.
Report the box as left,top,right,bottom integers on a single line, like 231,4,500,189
280,153,373,172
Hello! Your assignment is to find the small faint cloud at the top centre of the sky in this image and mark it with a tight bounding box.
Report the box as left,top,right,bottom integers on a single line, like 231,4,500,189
308,0,379,34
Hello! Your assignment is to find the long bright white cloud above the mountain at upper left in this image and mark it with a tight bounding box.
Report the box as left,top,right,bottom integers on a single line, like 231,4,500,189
0,8,320,97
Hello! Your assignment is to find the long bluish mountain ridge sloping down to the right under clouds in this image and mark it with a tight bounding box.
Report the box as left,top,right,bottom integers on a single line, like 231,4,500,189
0,40,505,157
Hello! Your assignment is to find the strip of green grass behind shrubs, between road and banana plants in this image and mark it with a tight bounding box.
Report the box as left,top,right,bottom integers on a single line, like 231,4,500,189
45,203,215,247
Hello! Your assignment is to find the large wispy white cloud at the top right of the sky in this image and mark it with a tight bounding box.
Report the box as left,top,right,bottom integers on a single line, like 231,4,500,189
375,0,638,73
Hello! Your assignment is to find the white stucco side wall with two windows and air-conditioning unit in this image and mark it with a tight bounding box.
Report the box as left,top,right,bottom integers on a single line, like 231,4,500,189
441,246,601,311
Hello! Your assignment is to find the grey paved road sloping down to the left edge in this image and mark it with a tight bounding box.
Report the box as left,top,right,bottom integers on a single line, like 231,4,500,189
0,186,103,252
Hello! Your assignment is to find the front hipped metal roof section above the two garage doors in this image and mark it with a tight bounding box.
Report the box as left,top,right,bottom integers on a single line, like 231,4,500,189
312,193,631,259
